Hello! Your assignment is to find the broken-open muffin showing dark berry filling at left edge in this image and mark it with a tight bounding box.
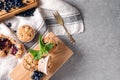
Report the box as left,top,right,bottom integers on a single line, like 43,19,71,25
0,34,24,58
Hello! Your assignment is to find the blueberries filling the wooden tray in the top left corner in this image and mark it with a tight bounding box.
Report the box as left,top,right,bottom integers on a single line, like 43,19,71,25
0,0,26,12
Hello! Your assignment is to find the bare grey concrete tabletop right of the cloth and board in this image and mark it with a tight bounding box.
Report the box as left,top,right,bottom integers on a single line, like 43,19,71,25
51,0,120,80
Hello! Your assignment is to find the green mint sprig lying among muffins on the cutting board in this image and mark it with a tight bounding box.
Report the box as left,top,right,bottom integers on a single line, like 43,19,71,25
29,35,53,60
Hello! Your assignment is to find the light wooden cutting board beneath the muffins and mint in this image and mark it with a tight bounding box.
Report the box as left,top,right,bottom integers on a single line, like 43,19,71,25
10,33,73,80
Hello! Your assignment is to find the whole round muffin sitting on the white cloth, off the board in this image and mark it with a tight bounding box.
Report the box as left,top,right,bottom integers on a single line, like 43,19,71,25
17,25,35,42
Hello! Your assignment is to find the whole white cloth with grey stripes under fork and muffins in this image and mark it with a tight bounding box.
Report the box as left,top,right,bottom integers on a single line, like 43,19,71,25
0,0,84,80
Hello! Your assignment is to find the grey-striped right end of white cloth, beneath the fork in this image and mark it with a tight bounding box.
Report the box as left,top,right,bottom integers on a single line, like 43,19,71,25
39,0,84,35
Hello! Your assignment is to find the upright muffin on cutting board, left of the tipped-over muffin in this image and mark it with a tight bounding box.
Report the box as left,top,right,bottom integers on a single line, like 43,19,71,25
22,53,38,71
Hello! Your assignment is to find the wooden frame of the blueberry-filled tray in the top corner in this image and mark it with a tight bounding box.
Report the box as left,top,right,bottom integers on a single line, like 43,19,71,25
0,0,38,21
